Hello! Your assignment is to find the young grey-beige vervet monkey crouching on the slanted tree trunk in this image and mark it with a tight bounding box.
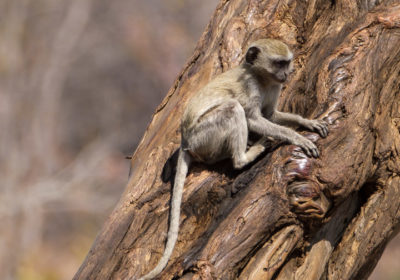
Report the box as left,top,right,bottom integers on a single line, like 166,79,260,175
140,39,328,280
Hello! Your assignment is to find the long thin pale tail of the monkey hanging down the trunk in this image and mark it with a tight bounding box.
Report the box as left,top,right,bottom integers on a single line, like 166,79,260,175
139,148,190,280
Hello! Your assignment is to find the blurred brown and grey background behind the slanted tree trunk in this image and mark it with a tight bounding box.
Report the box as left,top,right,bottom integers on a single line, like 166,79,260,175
0,0,400,280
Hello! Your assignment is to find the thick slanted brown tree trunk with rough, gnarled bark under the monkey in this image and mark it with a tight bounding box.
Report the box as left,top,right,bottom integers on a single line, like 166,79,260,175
74,0,400,280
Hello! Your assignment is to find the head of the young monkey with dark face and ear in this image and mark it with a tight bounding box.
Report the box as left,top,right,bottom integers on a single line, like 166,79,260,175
246,39,293,83
